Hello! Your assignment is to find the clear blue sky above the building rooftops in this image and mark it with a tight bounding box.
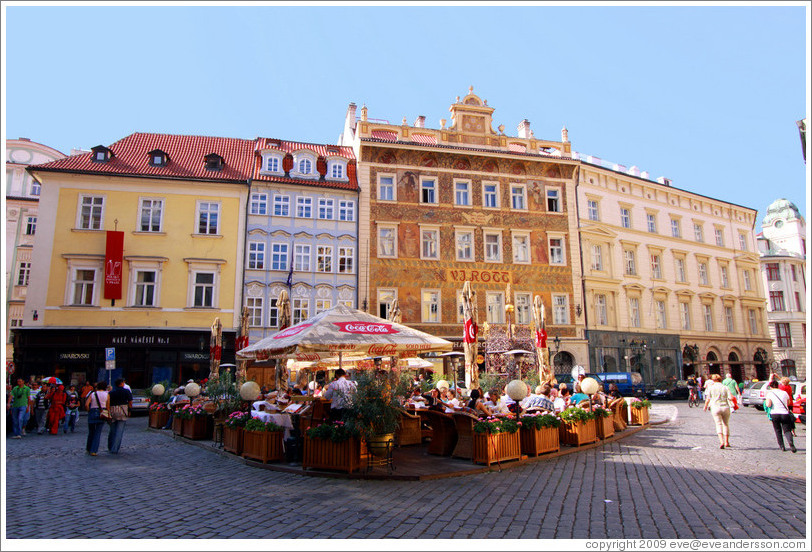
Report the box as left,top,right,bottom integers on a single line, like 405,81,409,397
4,4,809,222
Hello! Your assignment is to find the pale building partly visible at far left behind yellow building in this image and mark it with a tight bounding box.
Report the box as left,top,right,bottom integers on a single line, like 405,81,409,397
6,138,65,359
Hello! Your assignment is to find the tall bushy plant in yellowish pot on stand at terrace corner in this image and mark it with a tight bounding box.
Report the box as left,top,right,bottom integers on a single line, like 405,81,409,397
347,371,410,456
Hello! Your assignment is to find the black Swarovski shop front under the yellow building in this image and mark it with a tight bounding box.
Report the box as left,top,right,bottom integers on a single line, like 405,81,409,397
14,328,236,389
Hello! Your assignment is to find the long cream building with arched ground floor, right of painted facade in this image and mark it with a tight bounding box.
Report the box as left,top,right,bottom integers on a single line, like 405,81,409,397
575,154,772,384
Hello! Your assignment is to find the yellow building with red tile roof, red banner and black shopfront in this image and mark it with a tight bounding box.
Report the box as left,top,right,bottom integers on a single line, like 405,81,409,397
16,133,254,387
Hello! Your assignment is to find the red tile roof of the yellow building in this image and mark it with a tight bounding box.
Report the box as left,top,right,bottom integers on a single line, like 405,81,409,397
30,132,255,182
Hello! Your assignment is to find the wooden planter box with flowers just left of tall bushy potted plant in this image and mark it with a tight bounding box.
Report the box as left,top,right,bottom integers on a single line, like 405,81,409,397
302,421,361,473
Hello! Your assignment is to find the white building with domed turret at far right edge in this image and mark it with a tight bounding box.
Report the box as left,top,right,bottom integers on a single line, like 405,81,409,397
758,198,807,380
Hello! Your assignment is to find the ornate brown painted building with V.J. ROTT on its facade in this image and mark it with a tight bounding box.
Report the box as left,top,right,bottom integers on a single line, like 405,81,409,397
340,89,586,376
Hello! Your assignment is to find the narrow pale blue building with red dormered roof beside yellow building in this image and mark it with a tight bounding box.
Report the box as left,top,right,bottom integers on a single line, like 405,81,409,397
244,138,358,343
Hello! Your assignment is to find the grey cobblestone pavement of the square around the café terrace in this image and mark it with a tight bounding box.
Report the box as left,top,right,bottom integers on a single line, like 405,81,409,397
5,402,807,545
